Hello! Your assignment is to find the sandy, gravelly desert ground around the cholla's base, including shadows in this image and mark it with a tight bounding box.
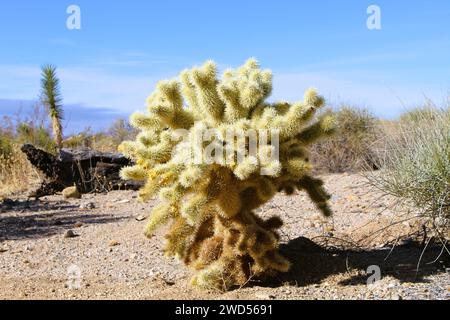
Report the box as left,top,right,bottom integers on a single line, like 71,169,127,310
0,174,450,299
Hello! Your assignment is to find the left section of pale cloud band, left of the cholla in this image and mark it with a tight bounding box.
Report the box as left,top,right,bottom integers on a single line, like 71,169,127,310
0,65,166,111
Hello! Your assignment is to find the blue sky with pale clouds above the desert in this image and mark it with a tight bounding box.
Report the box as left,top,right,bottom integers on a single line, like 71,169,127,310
0,0,450,130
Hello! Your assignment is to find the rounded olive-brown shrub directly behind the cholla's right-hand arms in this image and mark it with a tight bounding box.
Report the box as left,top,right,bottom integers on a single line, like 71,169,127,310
311,106,378,172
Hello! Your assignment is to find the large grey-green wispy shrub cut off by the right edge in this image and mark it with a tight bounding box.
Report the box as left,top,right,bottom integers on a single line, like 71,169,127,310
369,108,450,234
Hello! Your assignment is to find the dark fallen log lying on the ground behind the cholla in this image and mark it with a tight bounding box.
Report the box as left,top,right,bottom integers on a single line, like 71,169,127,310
21,144,142,198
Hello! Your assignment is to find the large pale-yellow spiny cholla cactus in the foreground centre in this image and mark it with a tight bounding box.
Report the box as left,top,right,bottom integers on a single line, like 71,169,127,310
119,59,333,289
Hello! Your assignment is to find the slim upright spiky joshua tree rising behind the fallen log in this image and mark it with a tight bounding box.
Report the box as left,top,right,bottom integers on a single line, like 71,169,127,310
41,65,63,149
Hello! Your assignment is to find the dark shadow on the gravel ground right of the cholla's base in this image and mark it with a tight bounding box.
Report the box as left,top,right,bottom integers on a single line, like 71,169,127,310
257,237,450,287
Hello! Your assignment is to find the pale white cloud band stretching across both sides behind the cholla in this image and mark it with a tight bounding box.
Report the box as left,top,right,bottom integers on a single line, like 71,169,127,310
0,65,448,117
